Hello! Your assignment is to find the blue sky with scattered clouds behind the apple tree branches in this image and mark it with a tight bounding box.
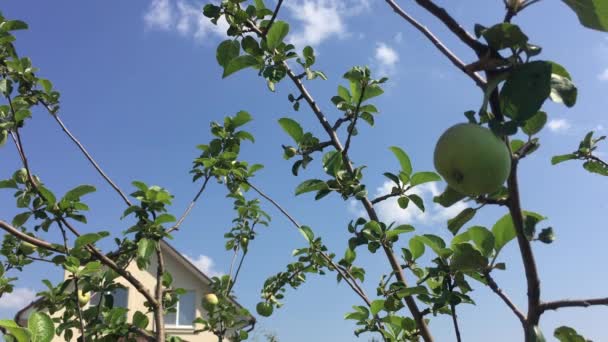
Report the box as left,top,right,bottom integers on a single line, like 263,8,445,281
0,0,608,342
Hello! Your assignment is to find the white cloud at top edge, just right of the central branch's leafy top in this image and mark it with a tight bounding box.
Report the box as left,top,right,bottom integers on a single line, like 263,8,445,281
285,0,369,47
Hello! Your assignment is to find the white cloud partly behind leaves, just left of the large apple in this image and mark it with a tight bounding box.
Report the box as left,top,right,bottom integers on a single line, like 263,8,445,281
349,181,468,225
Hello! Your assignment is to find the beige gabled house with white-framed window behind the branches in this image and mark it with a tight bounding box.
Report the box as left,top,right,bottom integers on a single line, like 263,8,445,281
15,241,255,342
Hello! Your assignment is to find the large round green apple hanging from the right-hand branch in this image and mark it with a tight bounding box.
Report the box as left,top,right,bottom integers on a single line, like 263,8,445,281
434,123,511,196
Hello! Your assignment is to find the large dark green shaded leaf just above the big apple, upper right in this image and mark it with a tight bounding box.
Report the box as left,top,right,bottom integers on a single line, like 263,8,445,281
500,61,552,122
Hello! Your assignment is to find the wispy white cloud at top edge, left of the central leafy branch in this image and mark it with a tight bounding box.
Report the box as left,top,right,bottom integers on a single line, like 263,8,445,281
144,0,228,40
